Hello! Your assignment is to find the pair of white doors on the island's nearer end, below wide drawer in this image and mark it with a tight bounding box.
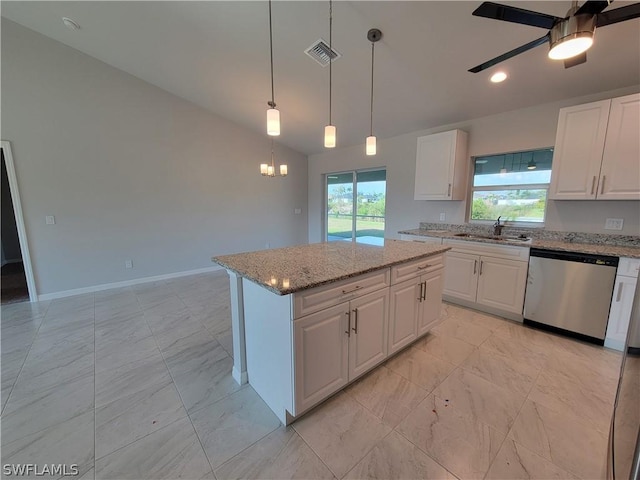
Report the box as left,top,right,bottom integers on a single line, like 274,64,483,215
293,288,389,412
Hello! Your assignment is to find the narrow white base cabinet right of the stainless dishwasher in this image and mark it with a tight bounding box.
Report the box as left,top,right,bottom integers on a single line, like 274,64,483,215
604,258,640,351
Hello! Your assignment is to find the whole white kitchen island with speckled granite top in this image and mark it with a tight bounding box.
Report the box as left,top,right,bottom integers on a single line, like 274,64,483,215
212,240,449,424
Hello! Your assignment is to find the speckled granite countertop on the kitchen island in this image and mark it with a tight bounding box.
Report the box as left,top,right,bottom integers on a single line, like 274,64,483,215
211,239,450,295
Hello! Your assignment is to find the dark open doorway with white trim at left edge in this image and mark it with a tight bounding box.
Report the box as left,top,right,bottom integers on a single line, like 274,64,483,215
0,141,37,305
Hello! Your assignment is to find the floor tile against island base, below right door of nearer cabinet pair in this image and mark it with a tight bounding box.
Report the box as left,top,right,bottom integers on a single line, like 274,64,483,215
346,367,427,428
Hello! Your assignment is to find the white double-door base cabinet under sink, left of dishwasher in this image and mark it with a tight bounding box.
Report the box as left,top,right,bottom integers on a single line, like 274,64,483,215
443,242,529,315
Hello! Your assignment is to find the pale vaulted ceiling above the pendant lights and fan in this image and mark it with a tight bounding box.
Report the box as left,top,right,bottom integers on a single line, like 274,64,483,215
2,0,640,154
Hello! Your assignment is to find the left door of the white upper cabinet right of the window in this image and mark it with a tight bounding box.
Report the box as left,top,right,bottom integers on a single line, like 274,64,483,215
549,100,612,200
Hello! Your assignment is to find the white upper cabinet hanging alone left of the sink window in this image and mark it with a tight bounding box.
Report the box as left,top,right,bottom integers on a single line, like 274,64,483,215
414,130,469,200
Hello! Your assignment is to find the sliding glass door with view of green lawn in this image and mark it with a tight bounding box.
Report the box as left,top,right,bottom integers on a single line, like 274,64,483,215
325,169,387,245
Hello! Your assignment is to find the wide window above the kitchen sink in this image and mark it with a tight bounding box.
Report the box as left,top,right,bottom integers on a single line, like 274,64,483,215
469,148,553,225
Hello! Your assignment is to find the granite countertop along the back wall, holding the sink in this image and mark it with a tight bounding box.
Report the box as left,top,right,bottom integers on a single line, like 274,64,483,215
398,228,640,258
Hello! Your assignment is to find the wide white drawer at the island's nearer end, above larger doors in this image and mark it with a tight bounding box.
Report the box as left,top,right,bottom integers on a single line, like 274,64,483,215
293,268,389,318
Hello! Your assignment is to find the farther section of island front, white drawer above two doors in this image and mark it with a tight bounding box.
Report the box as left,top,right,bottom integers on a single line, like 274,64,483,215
389,255,444,354
